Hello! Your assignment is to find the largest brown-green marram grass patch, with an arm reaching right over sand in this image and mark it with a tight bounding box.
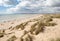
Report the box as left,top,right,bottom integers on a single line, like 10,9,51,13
30,17,56,35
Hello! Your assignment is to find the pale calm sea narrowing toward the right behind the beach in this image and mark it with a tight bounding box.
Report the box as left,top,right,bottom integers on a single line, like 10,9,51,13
0,14,36,23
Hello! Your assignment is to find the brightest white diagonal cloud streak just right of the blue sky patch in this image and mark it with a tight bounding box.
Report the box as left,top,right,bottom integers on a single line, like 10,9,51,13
7,1,29,13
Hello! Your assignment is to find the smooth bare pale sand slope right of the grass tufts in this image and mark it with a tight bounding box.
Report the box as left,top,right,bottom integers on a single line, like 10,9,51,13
35,19,60,41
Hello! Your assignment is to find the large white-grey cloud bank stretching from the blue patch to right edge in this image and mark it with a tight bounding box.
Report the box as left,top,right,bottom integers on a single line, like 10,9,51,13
7,0,60,13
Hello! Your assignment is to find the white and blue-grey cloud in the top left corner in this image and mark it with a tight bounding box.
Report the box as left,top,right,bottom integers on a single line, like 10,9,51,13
0,0,17,7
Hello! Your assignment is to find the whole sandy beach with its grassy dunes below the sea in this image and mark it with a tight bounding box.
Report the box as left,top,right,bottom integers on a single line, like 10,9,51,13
0,14,60,41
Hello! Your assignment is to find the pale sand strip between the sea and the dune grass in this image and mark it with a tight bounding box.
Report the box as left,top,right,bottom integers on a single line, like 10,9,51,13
0,14,42,29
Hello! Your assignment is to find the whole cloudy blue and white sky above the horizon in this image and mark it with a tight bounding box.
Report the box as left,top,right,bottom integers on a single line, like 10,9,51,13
0,0,60,14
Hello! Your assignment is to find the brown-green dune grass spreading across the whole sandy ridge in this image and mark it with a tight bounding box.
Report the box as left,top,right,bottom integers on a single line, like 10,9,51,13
0,14,60,41
